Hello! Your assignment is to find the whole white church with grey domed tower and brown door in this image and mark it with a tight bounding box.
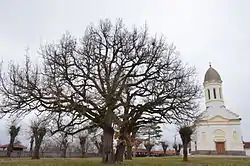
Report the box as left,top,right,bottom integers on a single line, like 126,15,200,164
191,65,245,155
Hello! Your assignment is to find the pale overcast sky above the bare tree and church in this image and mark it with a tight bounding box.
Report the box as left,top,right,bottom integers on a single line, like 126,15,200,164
0,0,250,147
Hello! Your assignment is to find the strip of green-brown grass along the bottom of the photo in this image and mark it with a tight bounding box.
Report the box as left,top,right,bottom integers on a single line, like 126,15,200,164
0,157,250,166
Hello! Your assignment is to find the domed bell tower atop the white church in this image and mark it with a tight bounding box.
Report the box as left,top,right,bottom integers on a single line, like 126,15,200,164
203,63,224,108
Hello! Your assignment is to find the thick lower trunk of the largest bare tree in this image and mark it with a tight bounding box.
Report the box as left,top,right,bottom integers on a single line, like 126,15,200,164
102,125,114,164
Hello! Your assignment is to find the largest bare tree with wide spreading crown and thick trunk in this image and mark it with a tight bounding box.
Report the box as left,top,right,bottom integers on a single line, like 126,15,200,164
0,20,199,163
